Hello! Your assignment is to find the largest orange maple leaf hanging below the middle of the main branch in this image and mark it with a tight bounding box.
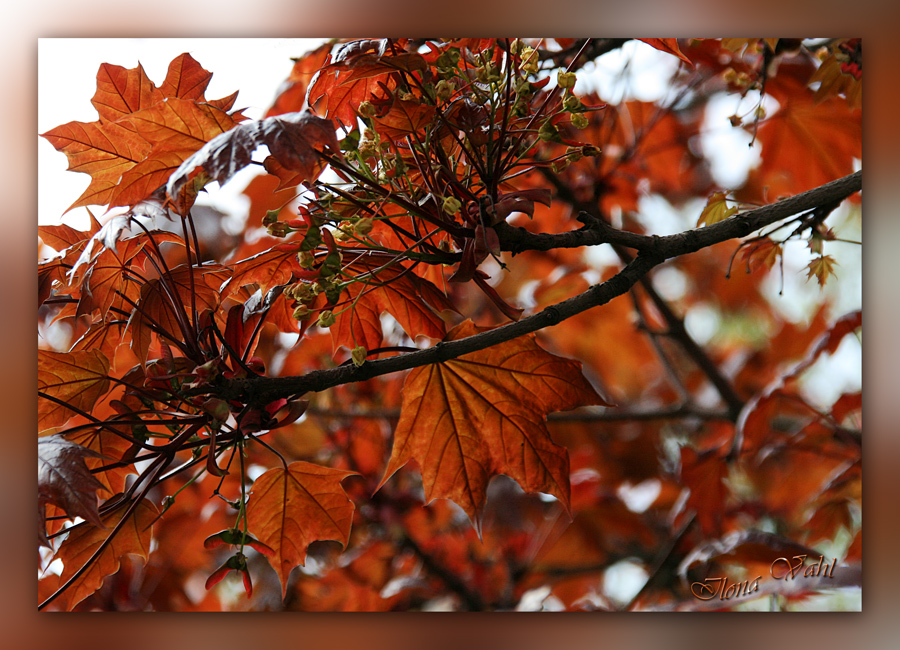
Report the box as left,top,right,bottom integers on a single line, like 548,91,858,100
379,321,609,528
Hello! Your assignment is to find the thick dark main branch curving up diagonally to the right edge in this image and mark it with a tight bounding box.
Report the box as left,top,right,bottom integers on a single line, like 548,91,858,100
207,171,862,404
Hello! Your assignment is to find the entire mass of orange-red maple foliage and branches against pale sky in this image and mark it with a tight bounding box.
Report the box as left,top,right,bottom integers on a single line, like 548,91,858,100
38,39,862,611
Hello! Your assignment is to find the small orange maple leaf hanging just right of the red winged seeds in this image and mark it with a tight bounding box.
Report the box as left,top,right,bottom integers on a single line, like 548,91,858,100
247,461,356,597
